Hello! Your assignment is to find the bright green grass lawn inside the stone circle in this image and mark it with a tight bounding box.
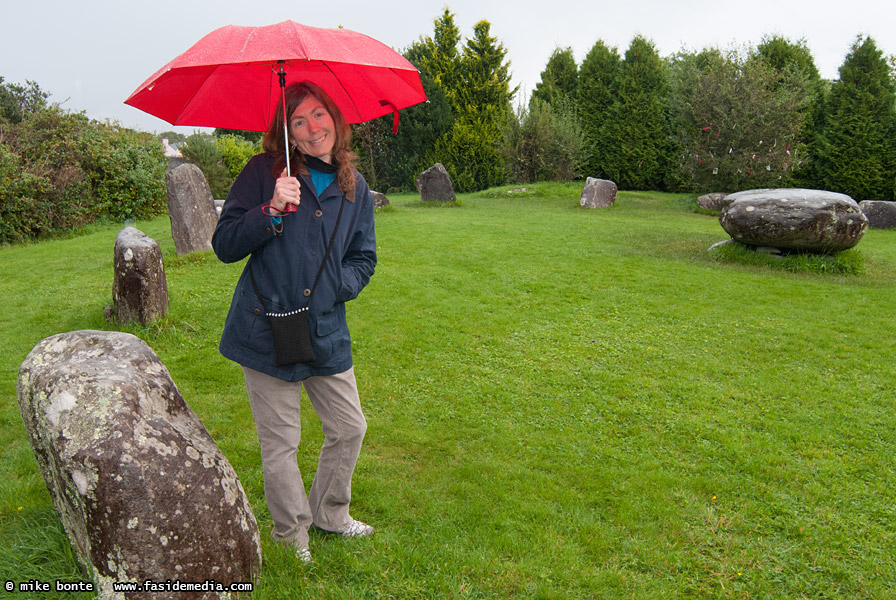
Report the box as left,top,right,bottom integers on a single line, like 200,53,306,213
0,184,896,599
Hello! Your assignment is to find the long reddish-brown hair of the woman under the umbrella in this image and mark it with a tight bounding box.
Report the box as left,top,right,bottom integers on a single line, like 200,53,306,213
261,81,358,202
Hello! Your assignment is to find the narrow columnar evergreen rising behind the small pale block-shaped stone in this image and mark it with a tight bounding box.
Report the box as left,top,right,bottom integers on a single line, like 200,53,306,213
576,40,621,178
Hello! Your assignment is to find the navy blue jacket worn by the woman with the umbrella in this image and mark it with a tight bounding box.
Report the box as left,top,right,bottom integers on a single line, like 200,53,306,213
212,154,376,381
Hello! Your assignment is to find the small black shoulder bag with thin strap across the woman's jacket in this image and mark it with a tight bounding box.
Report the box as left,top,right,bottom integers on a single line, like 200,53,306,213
249,196,345,367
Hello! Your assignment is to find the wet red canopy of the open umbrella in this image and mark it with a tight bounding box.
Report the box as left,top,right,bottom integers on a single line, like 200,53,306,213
125,21,426,131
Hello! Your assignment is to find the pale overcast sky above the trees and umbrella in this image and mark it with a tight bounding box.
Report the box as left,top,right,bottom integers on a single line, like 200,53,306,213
0,0,896,133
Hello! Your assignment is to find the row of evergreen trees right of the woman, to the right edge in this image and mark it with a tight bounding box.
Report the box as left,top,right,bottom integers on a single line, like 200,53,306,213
355,8,896,200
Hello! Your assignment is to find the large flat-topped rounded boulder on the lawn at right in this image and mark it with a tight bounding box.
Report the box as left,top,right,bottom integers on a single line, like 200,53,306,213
719,189,868,253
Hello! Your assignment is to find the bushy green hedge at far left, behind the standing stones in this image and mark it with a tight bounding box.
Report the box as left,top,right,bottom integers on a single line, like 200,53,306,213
0,106,167,243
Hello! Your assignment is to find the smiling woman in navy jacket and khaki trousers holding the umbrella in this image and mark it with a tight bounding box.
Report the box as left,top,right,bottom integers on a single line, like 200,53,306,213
212,82,376,562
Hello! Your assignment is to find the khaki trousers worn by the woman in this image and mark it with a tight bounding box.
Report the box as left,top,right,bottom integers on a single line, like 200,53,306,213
243,367,367,547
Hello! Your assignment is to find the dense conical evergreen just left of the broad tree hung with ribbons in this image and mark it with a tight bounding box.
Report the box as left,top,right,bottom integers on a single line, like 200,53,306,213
603,36,669,190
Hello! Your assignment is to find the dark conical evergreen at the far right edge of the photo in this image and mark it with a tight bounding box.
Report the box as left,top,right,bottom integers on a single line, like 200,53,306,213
818,37,896,201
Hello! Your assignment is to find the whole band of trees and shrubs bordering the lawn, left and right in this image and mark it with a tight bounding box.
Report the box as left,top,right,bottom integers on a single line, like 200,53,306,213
0,8,896,243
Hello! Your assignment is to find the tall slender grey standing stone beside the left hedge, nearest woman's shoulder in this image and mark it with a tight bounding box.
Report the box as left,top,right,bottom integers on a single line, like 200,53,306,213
165,164,218,255
